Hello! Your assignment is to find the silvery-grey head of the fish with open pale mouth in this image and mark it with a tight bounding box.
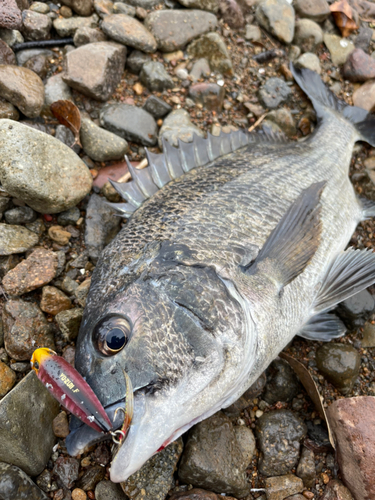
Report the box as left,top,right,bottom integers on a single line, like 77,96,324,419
68,252,250,482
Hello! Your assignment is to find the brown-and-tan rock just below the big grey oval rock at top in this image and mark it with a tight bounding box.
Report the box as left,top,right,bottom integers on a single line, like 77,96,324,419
188,33,232,73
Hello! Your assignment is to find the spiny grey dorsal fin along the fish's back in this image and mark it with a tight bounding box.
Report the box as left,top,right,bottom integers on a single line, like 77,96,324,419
108,130,286,217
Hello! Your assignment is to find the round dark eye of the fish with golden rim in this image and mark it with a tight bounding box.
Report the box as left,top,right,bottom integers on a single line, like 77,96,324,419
94,316,131,356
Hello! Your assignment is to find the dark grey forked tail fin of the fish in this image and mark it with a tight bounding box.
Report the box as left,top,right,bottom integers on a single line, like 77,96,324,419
290,63,375,146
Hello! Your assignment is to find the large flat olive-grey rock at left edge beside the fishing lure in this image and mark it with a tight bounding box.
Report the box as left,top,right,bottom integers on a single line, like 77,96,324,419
0,374,59,474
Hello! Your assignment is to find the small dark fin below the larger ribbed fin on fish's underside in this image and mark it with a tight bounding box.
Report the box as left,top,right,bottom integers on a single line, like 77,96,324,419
297,313,346,342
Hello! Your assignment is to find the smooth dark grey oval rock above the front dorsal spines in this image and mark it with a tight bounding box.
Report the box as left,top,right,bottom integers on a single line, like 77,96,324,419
100,104,158,146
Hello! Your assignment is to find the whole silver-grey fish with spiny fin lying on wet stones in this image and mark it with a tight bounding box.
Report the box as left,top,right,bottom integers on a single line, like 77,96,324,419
66,66,375,482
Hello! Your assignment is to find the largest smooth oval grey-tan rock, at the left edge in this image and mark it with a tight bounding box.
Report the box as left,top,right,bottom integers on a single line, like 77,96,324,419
0,120,92,214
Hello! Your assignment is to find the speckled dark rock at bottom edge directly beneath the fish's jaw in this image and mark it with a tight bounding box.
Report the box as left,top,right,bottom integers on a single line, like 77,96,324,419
123,438,183,500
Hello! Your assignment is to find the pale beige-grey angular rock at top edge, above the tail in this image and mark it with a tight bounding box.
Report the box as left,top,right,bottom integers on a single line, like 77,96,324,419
255,0,295,43
